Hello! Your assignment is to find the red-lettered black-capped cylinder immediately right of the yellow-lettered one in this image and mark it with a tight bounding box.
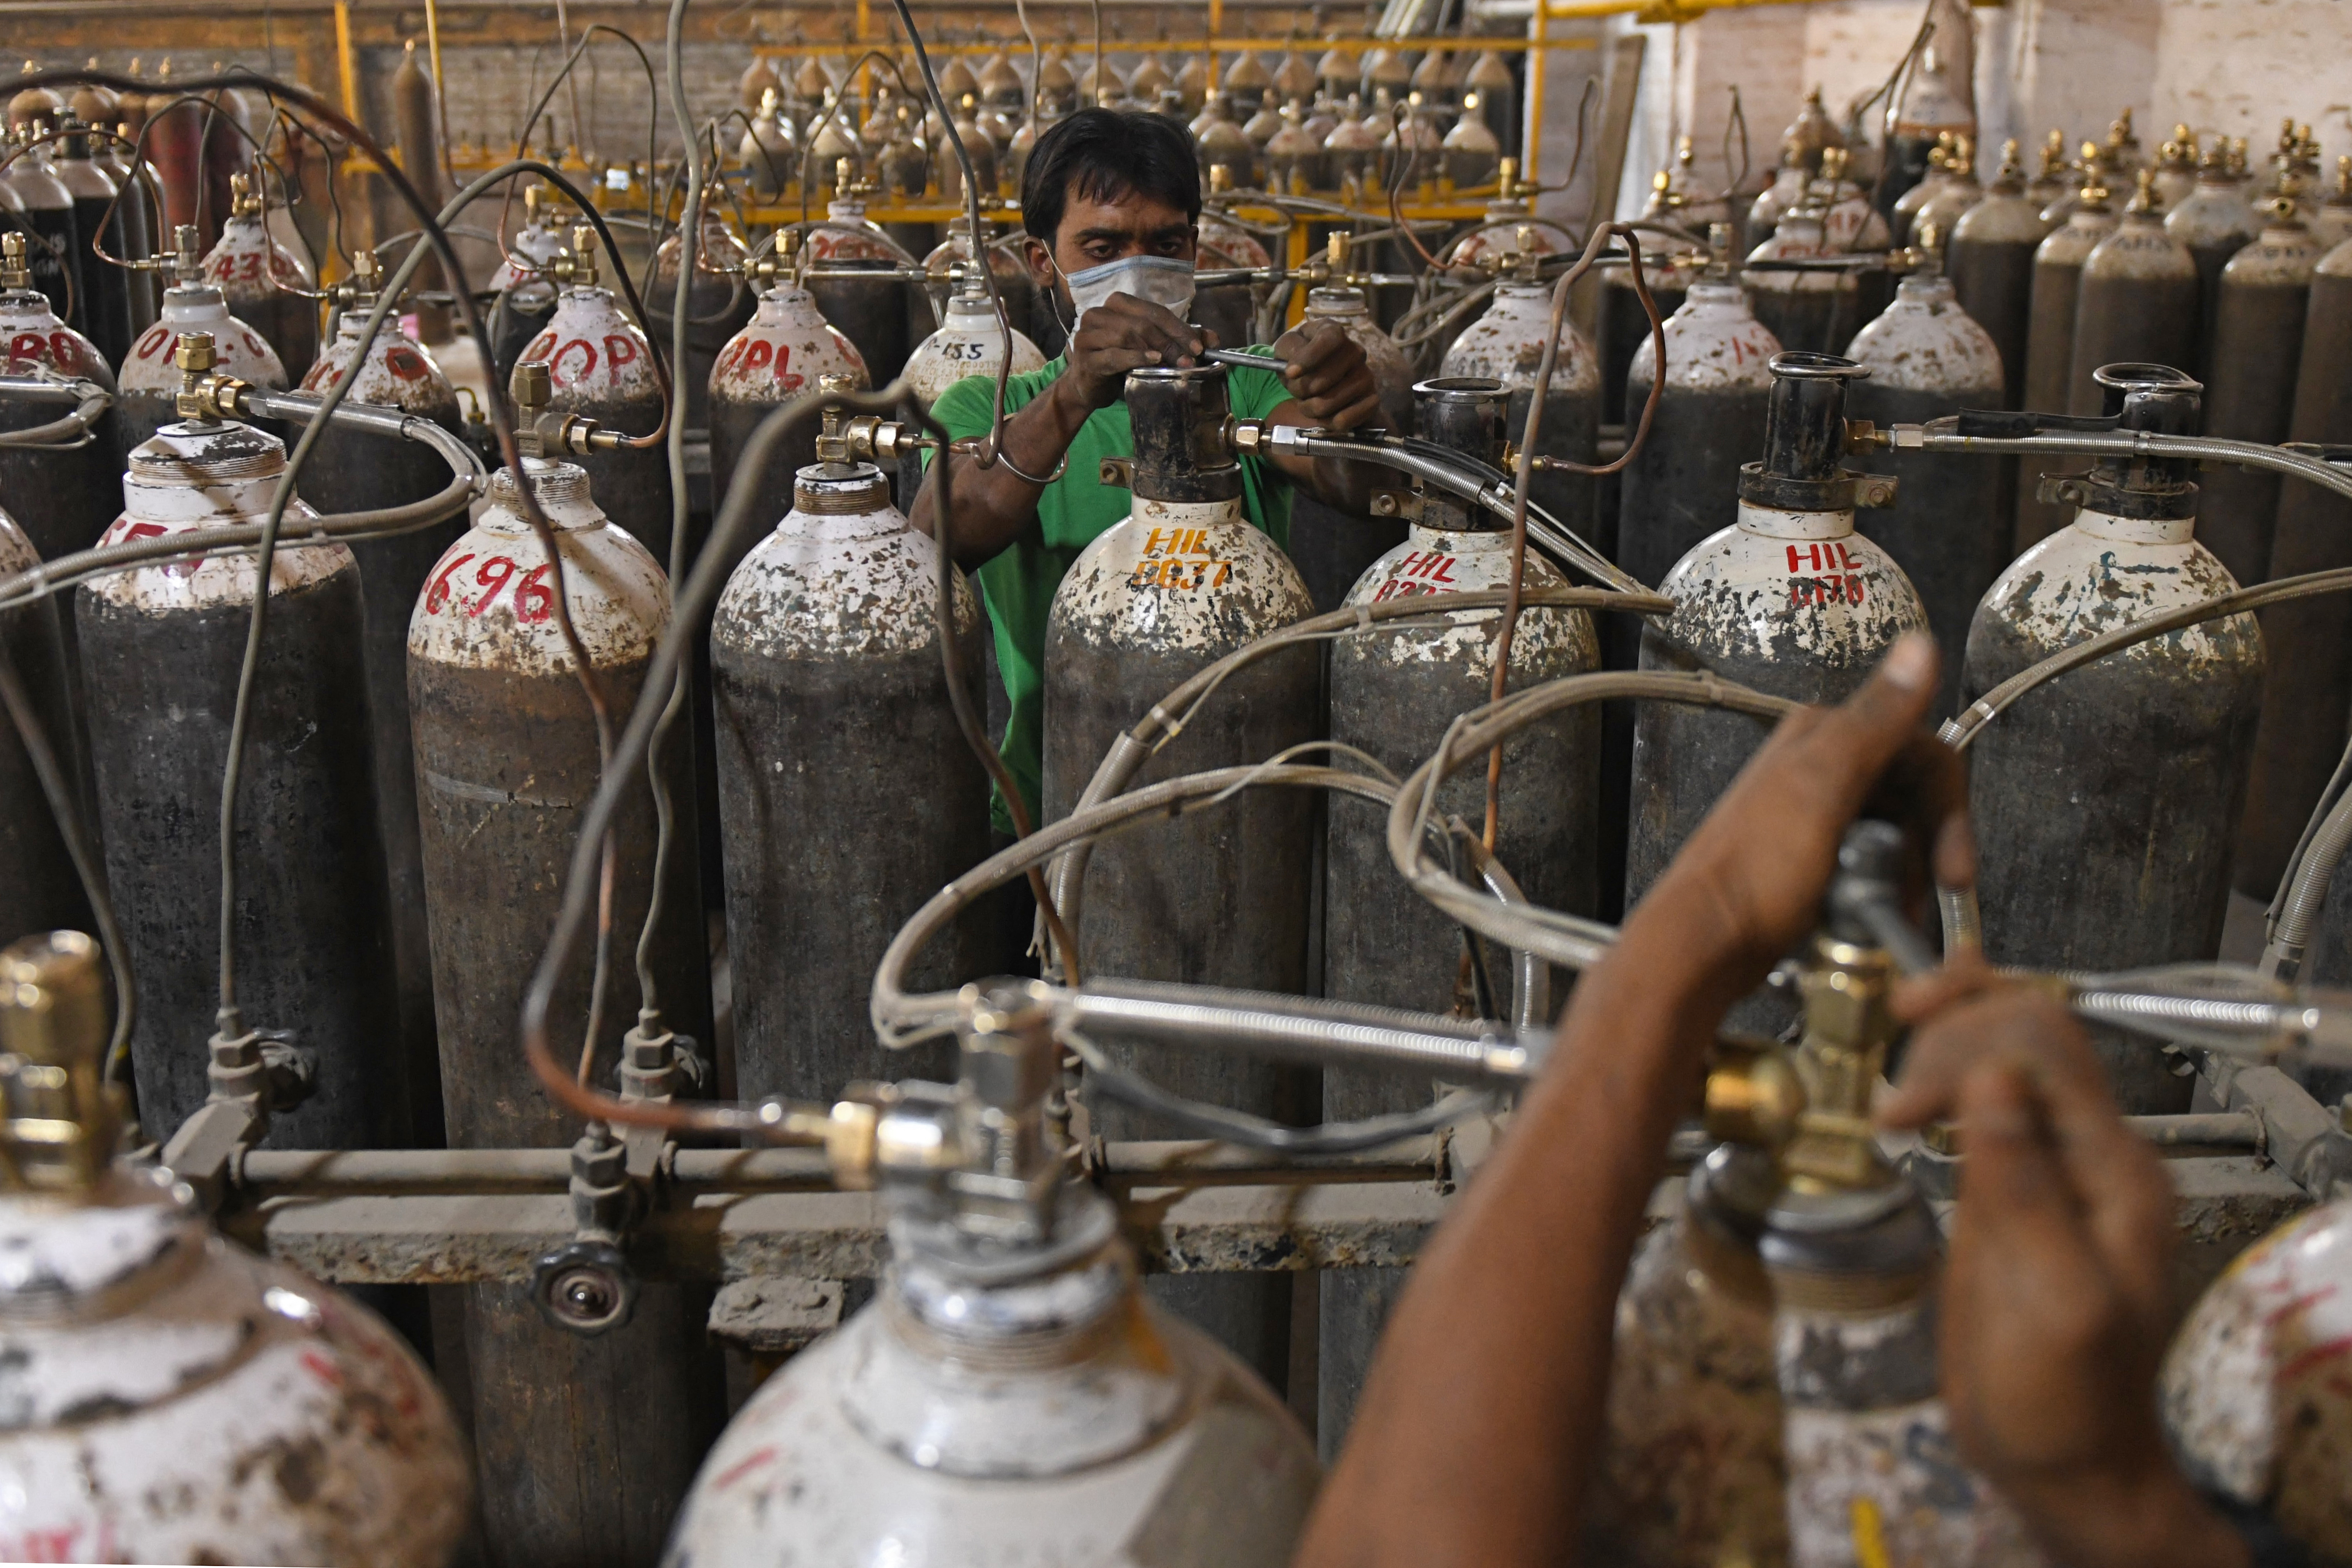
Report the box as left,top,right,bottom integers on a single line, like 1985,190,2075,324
1326,378,1602,1455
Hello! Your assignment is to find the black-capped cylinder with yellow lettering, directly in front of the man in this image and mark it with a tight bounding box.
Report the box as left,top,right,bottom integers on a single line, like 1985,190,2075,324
1044,365,1322,1387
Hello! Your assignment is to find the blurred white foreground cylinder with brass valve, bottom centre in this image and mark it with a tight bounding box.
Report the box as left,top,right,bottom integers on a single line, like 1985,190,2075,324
663,985,1317,1568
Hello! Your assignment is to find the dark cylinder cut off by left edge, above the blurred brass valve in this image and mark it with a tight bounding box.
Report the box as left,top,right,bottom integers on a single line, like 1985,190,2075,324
0,513,89,940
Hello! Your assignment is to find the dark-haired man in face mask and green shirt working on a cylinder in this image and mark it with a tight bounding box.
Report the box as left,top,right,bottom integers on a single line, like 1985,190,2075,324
913,108,1380,832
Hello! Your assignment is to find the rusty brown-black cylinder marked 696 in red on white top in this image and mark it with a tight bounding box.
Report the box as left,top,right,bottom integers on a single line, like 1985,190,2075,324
407,420,722,1566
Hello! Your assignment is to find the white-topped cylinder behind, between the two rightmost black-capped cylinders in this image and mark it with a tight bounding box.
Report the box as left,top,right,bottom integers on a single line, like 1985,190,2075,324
1846,248,2009,719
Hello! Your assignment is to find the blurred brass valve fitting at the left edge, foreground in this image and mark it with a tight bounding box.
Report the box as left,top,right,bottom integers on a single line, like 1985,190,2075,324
0,931,122,1194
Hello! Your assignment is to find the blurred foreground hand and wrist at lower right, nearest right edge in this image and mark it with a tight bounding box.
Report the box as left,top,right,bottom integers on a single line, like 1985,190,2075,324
1879,973,2246,1568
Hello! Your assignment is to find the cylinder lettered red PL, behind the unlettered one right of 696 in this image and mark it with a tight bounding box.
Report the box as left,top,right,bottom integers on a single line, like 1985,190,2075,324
710,277,870,569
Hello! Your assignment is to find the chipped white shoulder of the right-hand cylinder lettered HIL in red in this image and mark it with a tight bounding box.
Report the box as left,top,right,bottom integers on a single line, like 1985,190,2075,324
1658,501,1926,668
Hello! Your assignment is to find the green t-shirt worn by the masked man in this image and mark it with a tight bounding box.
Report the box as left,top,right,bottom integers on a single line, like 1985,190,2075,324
924,348,1291,832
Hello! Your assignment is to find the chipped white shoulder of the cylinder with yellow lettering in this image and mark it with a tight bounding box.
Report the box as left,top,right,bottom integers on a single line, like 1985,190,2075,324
1049,496,1315,656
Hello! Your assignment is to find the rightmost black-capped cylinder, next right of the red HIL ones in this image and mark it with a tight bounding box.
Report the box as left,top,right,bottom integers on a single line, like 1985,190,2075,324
1962,365,2265,1114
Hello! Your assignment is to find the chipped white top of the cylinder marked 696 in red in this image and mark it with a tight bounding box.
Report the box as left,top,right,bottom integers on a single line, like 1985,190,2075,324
409,459,670,675
